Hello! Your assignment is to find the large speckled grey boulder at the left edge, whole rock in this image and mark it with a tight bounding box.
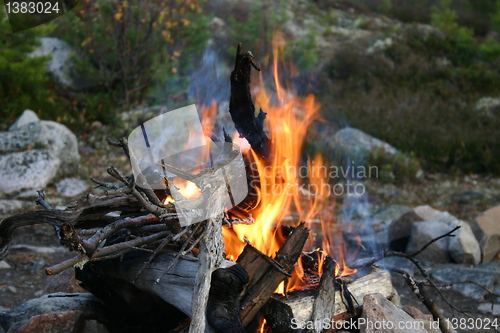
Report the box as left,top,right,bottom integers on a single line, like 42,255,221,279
0,110,80,194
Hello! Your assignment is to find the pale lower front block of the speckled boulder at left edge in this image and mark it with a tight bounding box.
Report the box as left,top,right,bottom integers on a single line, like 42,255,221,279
0,149,61,194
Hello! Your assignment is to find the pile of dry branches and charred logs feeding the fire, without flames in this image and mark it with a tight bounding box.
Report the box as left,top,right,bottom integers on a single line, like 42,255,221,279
0,45,492,333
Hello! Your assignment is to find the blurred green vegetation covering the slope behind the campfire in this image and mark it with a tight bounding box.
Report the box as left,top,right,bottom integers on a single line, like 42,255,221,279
0,0,500,174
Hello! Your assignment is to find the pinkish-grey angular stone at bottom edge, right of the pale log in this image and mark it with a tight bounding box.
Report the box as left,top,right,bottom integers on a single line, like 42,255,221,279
360,294,427,333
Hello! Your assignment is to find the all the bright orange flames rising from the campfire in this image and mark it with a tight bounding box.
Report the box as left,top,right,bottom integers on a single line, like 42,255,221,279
203,35,356,292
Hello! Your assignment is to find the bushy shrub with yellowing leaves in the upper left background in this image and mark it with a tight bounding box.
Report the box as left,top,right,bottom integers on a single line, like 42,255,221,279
55,0,208,122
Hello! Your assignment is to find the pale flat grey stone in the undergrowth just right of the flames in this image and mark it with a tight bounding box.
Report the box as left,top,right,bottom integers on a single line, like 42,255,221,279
333,128,398,155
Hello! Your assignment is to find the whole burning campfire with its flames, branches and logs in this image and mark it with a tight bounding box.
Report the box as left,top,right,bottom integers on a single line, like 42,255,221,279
0,36,464,332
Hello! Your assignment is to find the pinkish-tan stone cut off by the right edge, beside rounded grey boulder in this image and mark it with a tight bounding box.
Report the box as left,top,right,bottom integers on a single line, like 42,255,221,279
475,206,500,262
